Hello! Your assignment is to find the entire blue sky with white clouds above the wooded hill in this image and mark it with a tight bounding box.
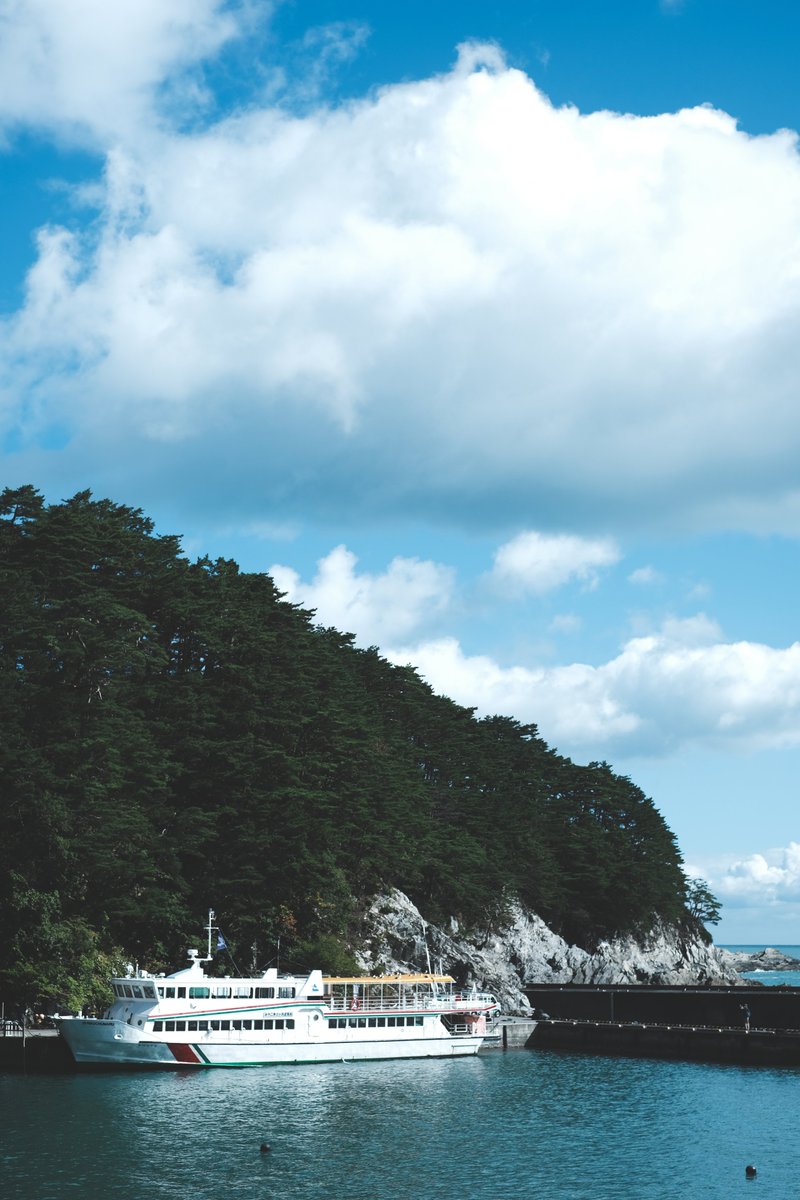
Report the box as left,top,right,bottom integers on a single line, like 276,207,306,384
0,0,800,942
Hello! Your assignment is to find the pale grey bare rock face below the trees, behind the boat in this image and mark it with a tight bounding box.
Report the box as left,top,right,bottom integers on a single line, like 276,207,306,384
360,890,742,1015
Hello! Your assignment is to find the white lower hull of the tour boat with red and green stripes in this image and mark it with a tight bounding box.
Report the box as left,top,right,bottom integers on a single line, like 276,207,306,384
58,1018,483,1069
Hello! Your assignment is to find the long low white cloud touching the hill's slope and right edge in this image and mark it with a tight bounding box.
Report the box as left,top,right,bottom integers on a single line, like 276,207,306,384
389,616,800,757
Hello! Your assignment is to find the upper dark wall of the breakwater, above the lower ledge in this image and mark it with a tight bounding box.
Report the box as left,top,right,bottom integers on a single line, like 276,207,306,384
525,984,800,1031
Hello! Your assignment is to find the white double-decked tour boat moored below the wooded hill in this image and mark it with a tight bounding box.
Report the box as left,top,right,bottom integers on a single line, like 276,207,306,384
56,912,500,1067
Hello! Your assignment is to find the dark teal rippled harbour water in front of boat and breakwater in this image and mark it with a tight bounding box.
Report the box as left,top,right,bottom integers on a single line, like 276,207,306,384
0,1050,800,1200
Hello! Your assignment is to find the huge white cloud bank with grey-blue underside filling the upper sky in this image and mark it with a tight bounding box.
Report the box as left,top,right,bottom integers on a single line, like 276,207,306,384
0,14,800,529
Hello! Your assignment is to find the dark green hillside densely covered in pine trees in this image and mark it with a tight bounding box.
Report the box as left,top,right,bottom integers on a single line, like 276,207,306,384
0,487,686,1003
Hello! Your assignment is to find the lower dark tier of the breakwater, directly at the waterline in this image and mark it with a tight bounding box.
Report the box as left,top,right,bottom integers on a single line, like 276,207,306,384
527,1020,800,1067
